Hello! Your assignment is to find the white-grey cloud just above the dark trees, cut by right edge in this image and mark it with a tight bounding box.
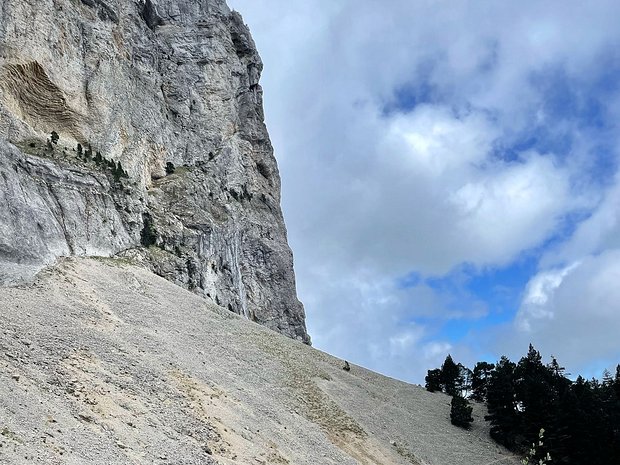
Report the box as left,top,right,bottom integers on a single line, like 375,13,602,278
517,249,620,369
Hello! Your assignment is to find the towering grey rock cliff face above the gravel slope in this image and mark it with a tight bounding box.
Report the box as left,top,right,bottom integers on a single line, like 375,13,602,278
0,0,309,343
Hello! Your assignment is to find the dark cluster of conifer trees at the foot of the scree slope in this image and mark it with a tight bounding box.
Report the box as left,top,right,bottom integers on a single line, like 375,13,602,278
426,345,620,465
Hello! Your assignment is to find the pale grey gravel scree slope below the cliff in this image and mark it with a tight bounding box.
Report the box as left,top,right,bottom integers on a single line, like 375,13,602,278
0,259,518,465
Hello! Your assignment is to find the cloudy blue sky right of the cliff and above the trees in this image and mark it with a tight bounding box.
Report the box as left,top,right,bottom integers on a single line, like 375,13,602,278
229,0,620,383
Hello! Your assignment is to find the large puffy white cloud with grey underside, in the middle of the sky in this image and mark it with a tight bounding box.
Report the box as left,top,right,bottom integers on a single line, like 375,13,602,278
284,106,575,278
